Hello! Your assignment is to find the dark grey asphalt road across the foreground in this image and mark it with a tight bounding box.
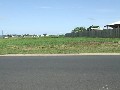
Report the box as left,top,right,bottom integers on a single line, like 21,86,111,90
0,56,120,90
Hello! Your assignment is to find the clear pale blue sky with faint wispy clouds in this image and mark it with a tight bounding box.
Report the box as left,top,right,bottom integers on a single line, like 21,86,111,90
0,0,120,35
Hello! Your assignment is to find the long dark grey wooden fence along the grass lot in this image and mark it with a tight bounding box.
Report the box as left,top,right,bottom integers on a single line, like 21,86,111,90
65,29,120,38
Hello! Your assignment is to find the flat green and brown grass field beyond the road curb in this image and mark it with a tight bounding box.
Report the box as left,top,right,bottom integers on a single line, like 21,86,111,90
0,37,120,54
